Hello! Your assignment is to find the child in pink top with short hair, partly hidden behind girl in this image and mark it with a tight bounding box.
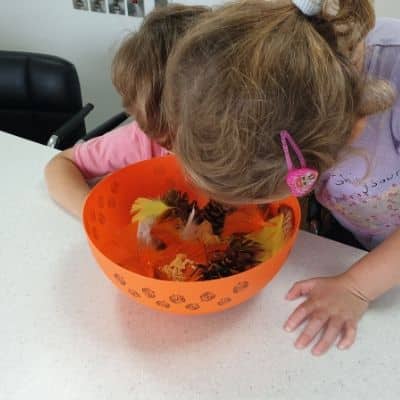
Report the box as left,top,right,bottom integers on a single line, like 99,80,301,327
45,4,209,218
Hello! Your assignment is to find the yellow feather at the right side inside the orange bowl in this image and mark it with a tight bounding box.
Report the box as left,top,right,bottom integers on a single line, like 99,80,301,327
246,214,285,261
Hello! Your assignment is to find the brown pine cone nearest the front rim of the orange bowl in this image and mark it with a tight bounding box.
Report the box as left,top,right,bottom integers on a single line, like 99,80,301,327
203,236,262,280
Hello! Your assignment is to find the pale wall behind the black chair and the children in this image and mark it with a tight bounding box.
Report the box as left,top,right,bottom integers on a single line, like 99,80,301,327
0,0,400,129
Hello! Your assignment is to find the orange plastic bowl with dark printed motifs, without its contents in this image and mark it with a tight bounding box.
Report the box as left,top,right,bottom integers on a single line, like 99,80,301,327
83,156,300,315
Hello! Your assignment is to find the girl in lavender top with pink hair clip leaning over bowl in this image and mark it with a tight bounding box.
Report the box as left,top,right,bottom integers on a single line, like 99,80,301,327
165,0,400,355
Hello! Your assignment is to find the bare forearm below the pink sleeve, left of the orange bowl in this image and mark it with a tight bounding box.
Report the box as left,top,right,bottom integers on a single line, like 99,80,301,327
45,148,90,218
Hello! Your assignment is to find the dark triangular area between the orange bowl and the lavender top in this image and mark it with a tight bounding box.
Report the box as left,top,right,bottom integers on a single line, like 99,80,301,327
307,194,366,250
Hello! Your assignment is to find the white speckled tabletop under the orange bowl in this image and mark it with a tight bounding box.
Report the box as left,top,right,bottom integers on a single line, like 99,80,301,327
0,133,400,400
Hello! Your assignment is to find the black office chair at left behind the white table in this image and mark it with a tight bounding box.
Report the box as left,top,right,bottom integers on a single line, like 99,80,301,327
0,51,93,149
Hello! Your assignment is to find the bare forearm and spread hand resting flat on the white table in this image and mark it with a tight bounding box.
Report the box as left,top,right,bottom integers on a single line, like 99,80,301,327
285,230,400,355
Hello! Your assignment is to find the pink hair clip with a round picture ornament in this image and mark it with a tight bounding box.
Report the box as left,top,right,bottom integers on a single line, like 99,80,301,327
281,131,318,197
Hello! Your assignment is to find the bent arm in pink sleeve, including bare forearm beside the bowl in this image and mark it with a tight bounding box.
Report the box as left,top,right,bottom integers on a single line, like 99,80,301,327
45,122,167,218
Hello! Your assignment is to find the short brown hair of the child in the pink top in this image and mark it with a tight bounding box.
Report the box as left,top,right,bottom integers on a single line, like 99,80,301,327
112,4,209,138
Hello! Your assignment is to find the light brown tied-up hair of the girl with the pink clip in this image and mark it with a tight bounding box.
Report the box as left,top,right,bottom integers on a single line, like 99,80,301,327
165,0,393,202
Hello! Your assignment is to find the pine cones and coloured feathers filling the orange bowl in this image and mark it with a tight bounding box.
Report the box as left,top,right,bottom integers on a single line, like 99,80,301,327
131,189,294,282
